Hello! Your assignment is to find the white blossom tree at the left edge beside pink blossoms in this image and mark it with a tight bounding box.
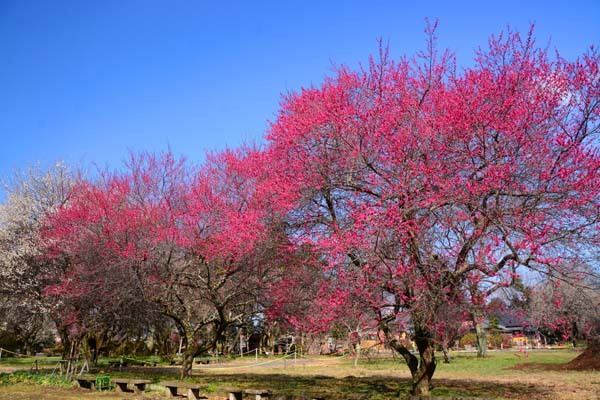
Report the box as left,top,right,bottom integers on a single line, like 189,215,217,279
0,162,75,351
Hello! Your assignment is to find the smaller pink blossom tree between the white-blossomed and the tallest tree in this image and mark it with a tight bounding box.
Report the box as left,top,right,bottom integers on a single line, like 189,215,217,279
44,150,277,377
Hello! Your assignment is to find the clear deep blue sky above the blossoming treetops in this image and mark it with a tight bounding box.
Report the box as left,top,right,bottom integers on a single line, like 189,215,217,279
0,0,600,200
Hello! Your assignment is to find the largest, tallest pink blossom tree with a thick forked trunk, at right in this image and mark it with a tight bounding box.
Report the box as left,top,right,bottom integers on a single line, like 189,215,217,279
266,25,600,395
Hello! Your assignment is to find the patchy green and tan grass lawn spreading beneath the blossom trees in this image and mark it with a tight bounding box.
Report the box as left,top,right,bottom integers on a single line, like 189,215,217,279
0,350,600,400
